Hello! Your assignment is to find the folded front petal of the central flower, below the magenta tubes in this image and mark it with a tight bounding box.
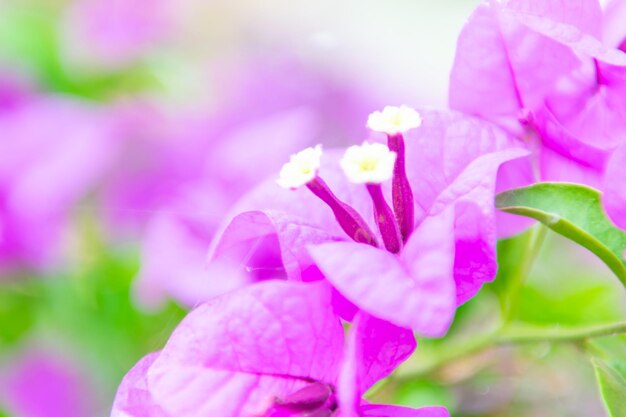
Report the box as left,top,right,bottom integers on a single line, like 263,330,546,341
309,213,455,336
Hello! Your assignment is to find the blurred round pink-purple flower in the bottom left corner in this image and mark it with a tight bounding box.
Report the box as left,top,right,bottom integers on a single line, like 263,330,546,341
0,352,96,417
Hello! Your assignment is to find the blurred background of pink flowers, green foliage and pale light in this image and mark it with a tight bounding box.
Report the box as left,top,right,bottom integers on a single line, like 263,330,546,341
0,0,626,417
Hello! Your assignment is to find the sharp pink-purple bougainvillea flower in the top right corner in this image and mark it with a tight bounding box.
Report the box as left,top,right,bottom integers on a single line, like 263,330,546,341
450,0,626,226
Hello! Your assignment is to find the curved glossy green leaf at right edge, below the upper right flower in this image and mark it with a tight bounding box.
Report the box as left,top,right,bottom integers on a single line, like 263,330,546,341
496,183,626,286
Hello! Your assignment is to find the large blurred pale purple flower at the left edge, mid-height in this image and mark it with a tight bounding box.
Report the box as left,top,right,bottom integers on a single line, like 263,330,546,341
0,92,115,268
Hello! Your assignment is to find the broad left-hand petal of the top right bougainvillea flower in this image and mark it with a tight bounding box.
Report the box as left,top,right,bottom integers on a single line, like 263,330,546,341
449,1,579,117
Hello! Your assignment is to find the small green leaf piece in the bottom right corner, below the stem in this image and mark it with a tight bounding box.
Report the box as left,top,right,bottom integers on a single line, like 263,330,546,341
591,358,626,417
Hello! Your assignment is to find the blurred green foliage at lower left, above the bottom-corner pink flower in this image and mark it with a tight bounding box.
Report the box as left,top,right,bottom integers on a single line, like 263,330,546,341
0,247,185,398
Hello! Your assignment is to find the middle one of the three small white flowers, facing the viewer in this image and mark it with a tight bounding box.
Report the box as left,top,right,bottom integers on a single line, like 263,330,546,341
339,142,396,184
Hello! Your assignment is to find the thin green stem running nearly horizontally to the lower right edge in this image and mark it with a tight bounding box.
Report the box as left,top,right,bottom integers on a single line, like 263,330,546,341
394,321,626,381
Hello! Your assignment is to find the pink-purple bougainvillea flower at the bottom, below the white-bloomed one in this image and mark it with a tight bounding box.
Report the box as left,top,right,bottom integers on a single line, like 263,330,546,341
112,281,448,417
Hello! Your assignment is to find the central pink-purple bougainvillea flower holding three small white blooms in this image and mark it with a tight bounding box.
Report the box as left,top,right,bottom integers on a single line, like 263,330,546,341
210,107,526,336
